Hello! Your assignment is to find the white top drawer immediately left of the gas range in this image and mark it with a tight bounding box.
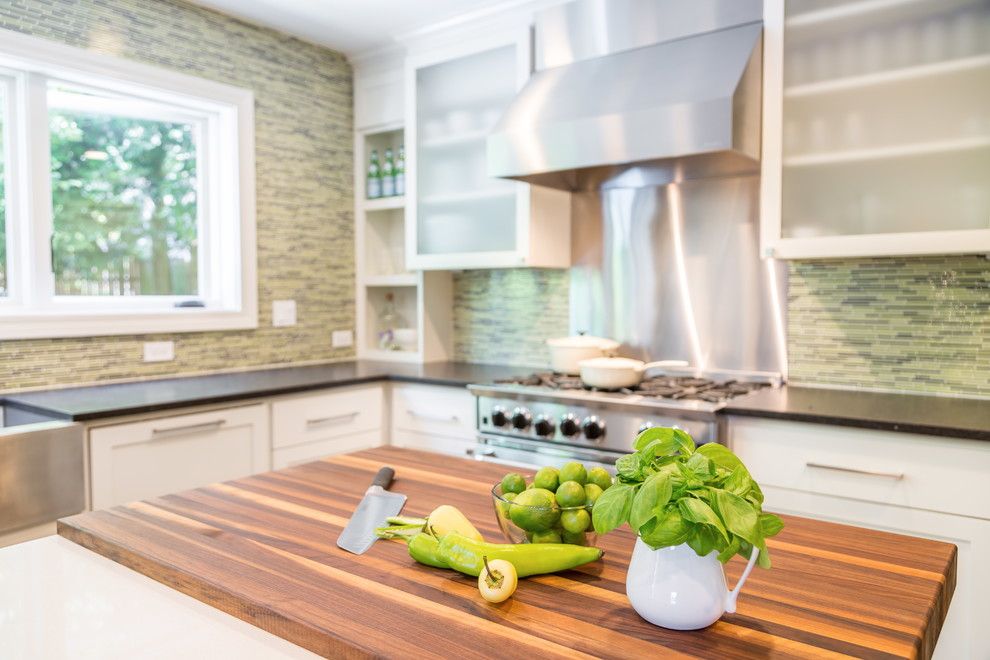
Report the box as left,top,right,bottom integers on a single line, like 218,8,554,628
392,385,475,442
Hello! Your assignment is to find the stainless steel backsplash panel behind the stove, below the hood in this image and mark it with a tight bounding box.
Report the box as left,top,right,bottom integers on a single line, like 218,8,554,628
570,175,787,374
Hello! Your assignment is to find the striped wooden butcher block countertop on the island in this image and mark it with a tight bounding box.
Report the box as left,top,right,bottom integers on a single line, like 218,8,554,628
59,447,956,660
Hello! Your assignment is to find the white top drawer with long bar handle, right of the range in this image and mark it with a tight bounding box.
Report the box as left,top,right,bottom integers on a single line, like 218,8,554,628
729,418,990,519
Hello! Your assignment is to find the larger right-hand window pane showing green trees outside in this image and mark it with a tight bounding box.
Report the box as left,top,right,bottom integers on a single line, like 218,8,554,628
49,88,199,296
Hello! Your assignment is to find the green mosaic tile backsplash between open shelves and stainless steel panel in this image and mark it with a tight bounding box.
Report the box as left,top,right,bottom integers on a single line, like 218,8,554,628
454,268,570,368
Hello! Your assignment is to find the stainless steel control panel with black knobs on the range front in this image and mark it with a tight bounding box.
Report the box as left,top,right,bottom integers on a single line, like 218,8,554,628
477,396,718,453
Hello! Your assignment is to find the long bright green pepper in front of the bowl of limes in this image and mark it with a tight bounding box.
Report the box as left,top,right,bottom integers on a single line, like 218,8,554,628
442,534,602,577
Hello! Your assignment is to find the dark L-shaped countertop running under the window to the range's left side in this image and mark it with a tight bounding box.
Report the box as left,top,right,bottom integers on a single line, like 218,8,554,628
0,360,533,421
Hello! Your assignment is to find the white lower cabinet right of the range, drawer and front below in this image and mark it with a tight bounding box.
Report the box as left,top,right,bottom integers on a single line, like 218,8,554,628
729,417,990,660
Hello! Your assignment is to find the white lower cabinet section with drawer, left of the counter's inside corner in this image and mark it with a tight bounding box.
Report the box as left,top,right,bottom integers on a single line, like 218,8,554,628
272,385,385,470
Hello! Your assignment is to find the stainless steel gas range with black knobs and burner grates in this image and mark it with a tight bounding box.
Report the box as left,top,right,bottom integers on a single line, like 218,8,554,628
468,372,781,467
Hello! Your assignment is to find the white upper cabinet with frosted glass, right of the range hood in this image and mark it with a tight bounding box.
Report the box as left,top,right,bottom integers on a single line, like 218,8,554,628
761,0,990,258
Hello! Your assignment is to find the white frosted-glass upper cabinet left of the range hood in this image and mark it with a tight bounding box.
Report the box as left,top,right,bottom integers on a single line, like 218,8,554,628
406,27,570,270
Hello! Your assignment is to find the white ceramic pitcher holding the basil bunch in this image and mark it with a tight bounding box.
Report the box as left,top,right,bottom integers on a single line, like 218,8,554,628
626,538,760,630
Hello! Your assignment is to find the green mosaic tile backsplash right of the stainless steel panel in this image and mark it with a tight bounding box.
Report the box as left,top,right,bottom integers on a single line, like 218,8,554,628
788,255,990,396
